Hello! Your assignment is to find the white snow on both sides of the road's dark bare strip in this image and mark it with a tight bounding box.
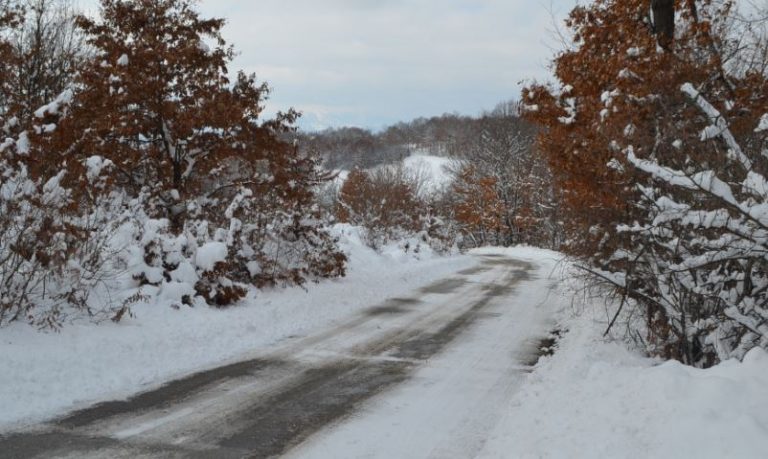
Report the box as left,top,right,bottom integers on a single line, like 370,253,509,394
0,243,768,458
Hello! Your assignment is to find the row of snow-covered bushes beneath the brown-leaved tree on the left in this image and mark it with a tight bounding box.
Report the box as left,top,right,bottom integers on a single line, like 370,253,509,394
0,128,345,328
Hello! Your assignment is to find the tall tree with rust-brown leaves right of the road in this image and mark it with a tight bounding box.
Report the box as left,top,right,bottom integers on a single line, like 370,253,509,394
524,0,747,255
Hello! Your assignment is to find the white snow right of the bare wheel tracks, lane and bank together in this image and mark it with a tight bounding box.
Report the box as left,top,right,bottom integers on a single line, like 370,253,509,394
291,249,768,459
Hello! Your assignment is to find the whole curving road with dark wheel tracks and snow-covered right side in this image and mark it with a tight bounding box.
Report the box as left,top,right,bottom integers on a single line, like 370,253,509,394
0,251,556,458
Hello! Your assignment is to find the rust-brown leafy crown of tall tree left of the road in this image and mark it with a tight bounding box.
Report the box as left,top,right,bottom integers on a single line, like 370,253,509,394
41,0,296,231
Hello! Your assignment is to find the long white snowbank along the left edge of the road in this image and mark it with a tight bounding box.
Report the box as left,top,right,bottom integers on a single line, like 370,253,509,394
0,226,473,432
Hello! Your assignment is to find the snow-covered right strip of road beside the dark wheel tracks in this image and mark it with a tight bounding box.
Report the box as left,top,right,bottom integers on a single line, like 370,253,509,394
287,249,561,459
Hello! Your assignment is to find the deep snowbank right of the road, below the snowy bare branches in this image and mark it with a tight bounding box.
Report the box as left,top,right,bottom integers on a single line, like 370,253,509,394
482,274,768,458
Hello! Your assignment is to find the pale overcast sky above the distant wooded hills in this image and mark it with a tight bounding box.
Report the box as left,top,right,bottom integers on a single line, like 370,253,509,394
80,0,576,129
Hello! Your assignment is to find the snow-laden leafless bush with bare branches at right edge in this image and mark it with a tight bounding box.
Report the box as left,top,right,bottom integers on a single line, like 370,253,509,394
600,84,768,365
